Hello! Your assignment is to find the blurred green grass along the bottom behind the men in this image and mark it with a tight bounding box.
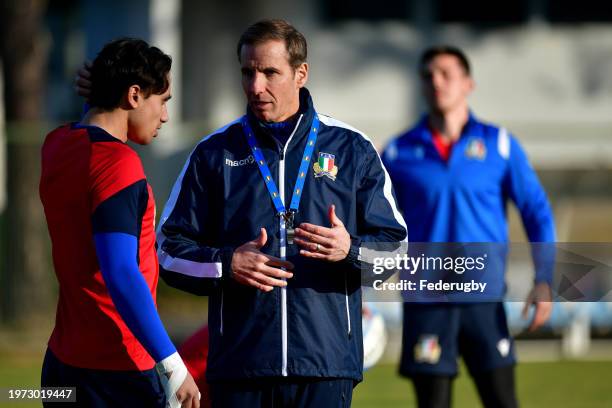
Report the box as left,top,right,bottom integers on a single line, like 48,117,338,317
0,355,612,408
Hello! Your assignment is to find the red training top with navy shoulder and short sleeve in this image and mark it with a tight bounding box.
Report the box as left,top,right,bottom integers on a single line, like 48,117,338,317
40,124,159,370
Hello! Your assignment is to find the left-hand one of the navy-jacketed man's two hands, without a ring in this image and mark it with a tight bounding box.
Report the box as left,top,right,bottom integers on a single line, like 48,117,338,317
232,228,293,292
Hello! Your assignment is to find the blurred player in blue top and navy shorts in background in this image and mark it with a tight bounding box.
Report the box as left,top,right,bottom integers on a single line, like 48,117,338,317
383,46,555,407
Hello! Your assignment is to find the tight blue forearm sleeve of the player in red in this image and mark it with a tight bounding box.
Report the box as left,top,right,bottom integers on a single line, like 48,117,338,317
94,232,176,362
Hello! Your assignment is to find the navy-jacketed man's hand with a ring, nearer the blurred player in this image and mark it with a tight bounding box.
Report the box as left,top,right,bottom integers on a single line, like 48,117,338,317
294,205,351,262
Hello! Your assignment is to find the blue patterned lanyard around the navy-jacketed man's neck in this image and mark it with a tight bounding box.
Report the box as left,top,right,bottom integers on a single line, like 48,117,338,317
242,113,319,224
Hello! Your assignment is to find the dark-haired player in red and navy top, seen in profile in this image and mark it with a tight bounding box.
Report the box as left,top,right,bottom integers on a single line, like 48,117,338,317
40,39,199,407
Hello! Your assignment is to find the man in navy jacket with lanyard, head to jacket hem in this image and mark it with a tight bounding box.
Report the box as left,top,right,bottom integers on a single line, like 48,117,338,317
158,20,406,398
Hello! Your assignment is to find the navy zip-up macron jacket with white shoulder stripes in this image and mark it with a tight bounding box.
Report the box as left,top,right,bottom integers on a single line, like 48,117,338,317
158,89,406,381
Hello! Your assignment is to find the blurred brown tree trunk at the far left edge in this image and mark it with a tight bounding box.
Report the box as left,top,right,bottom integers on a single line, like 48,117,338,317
0,0,52,324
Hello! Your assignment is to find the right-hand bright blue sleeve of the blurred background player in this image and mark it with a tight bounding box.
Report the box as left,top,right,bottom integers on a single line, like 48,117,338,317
506,137,556,284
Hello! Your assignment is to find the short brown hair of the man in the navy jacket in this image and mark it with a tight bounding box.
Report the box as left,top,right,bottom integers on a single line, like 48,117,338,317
236,19,308,69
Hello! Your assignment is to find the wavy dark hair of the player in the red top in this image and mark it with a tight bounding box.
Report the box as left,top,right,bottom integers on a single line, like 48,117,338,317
89,38,172,110
